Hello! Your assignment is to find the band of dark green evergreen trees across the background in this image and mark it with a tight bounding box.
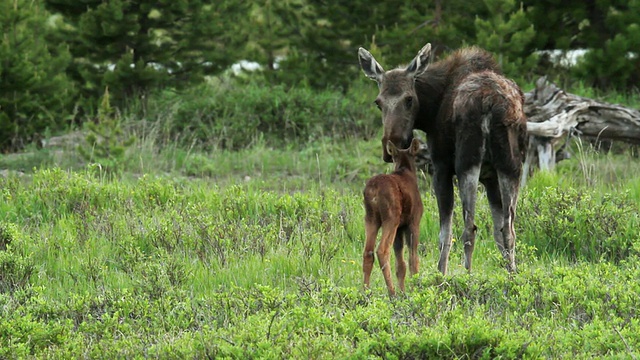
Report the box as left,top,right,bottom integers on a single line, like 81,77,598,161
0,0,640,151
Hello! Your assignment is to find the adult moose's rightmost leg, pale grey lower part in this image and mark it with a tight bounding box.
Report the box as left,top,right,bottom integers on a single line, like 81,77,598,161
498,173,520,272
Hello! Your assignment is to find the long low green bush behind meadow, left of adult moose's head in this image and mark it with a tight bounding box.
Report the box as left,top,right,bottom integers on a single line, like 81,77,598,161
145,82,379,149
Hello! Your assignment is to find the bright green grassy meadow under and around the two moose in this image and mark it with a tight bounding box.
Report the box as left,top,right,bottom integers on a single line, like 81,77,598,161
0,131,640,359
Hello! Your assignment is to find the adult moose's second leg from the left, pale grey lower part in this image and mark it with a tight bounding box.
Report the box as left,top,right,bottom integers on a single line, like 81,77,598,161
458,165,480,272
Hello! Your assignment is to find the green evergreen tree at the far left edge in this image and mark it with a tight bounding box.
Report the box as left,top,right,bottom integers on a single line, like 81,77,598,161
0,0,74,151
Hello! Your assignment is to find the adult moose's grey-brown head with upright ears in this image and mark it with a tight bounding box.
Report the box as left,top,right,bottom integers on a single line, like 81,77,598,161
358,44,431,162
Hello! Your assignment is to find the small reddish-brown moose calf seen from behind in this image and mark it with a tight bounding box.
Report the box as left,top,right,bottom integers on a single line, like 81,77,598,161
362,139,423,296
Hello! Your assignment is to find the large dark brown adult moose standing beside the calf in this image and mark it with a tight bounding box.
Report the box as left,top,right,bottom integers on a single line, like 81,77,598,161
358,44,527,274
